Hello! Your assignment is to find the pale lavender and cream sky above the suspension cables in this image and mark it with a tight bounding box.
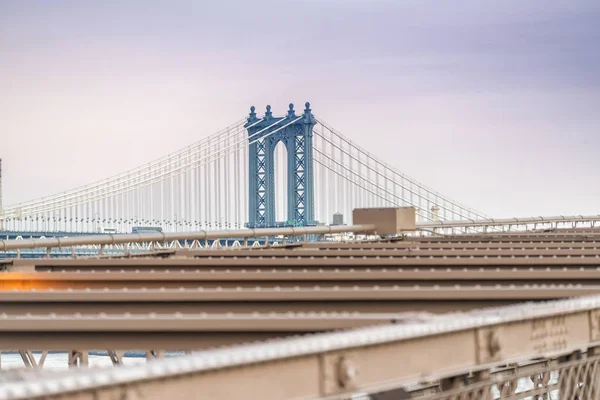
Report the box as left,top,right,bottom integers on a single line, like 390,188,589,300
0,0,600,217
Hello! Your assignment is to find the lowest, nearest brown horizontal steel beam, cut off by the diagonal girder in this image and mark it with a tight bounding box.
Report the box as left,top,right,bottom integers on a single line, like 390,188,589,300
0,313,406,350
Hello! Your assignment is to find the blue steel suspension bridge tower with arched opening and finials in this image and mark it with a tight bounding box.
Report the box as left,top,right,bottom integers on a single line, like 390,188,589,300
244,102,316,228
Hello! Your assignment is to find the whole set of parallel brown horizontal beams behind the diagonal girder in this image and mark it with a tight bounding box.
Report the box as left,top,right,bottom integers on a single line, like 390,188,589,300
5,231,600,372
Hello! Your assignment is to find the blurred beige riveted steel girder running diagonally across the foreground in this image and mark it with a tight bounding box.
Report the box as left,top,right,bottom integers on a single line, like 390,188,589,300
5,296,600,400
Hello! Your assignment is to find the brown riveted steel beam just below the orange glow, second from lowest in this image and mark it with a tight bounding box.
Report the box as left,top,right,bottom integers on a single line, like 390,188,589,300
0,285,600,302
